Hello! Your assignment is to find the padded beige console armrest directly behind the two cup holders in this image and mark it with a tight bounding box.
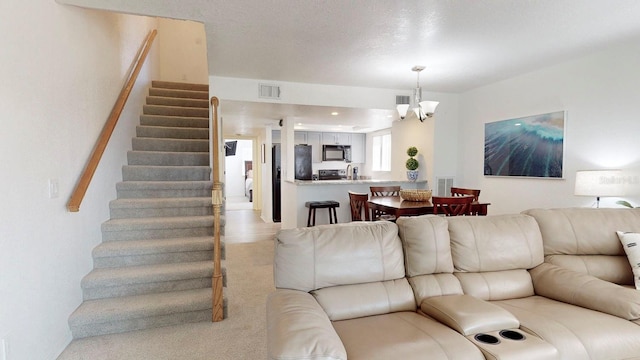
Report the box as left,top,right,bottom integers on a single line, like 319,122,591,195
420,295,520,336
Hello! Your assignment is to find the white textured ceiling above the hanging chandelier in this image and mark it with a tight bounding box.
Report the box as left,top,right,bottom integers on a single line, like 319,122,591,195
58,0,640,133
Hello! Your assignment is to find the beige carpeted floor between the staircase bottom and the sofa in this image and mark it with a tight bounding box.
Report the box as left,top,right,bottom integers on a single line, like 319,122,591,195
58,240,274,360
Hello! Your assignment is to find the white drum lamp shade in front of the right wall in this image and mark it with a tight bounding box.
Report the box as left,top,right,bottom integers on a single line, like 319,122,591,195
574,170,624,197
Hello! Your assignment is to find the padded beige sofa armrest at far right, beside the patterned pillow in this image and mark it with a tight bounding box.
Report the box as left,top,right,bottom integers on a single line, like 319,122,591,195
529,263,640,320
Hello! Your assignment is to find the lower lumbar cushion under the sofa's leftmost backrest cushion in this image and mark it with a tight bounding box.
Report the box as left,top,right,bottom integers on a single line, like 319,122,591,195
311,278,416,320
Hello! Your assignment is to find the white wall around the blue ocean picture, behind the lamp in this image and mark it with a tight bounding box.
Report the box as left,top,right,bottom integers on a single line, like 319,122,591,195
457,41,640,214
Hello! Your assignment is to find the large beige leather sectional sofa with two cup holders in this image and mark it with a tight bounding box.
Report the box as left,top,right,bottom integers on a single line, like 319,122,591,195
267,209,640,360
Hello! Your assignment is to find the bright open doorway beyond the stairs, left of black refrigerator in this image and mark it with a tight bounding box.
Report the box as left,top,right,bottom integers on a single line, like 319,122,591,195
224,138,254,211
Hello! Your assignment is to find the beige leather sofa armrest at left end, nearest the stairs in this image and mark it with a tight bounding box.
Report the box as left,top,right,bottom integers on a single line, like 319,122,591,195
267,289,347,360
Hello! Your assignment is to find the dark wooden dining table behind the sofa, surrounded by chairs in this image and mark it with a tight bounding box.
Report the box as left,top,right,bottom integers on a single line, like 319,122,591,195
369,196,491,218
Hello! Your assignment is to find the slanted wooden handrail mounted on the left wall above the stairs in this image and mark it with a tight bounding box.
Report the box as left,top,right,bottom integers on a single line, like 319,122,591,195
67,29,158,212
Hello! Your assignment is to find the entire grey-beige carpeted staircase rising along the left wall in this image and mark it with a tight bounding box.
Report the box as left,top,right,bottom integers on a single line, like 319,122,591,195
69,81,227,339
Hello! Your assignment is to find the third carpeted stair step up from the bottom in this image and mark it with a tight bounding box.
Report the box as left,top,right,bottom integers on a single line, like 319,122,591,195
92,236,226,268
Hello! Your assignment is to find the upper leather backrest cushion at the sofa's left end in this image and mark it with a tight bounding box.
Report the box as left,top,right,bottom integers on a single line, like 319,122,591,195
274,221,405,291
